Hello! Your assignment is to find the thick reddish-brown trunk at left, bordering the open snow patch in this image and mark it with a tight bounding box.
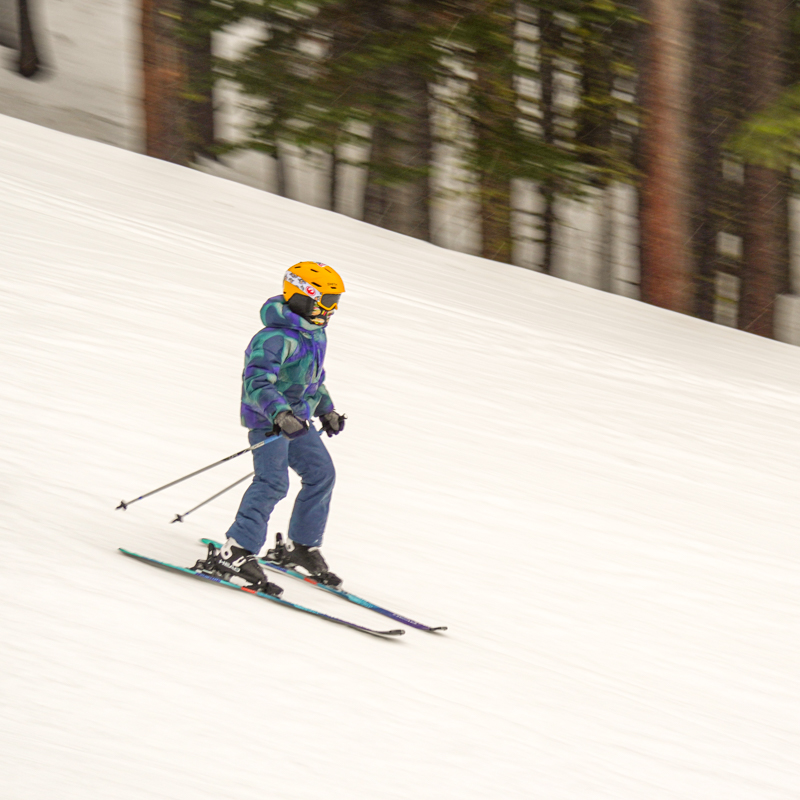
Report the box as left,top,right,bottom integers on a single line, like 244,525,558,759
142,0,190,164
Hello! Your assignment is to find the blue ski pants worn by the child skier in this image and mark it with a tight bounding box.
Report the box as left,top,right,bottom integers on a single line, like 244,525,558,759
223,426,336,553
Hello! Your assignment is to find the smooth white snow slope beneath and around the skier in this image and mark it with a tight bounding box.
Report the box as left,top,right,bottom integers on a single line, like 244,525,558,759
0,112,800,800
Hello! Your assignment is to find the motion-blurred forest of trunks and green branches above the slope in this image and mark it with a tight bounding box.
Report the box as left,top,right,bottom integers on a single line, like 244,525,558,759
0,0,800,343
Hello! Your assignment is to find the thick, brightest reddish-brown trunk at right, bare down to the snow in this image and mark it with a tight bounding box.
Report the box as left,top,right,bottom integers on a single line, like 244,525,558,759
639,0,691,313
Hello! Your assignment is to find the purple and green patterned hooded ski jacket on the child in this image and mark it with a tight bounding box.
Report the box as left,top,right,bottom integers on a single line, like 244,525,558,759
242,295,333,429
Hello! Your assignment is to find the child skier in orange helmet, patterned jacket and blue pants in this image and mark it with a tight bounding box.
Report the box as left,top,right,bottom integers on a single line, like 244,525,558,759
212,261,345,596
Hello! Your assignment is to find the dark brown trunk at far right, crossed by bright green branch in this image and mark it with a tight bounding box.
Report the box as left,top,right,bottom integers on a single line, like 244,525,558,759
738,0,787,338
